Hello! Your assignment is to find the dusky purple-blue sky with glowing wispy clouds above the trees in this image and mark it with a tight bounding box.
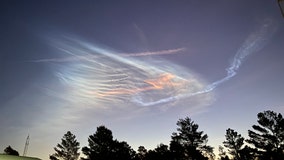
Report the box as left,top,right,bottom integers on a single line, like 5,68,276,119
0,0,284,159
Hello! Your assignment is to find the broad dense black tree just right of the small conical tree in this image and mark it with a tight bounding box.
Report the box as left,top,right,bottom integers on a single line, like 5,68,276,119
82,126,135,160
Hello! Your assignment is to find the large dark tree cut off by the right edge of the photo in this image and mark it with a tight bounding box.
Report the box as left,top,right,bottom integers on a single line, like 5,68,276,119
247,110,284,160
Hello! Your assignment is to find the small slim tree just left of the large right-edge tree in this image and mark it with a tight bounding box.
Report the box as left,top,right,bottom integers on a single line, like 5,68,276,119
223,128,244,160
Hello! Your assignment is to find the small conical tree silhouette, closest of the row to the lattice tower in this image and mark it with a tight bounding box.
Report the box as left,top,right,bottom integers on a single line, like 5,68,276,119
49,131,80,160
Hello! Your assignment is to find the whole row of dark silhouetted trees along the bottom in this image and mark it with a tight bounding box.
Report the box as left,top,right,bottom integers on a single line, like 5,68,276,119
43,110,284,160
